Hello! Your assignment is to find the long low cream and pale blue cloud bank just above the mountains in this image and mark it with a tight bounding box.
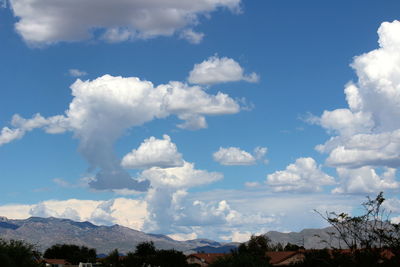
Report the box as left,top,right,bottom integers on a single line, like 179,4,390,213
0,191,366,241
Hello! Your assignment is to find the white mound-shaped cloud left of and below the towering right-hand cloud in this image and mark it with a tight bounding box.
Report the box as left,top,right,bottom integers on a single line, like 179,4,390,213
266,158,335,192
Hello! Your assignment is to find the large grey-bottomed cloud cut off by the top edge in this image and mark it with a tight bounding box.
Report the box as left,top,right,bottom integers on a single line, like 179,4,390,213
10,0,240,45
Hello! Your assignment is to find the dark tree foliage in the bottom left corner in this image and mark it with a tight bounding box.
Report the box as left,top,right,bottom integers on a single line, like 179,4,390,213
0,240,40,267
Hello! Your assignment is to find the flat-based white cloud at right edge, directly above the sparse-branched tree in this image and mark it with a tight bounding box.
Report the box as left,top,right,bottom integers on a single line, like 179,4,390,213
332,166,400,193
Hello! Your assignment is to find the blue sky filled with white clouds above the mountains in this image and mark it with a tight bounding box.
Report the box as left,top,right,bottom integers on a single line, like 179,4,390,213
0,0,400,241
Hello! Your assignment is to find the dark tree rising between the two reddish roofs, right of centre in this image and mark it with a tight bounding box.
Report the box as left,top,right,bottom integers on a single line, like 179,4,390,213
210,235,271,267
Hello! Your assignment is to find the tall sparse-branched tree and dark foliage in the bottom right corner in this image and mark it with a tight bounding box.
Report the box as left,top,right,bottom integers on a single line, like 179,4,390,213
296,192,400,267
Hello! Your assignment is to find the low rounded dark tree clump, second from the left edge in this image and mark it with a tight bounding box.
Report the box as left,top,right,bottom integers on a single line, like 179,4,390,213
43,244,96,265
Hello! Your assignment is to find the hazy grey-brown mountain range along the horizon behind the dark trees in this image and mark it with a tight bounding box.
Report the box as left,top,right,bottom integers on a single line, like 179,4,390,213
0,217,338,254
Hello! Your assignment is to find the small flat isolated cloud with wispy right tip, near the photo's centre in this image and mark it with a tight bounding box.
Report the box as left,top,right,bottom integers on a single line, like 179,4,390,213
213,147,267,165
